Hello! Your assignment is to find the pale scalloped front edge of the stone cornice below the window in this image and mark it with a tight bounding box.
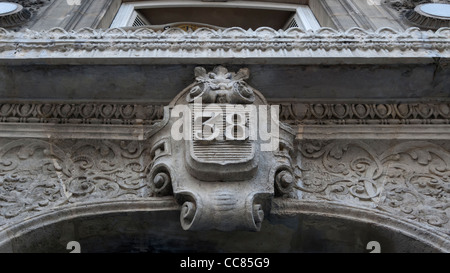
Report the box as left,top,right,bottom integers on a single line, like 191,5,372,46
0,27,450,64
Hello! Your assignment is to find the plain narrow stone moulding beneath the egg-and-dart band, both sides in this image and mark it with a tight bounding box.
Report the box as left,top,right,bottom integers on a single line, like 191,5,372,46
0,123,450,141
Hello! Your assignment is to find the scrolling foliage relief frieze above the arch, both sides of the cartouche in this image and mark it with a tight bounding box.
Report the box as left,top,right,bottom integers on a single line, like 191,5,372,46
0,139,450,234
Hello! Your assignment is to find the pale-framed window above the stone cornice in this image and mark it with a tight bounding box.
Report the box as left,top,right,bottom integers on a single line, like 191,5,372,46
111,1,320,30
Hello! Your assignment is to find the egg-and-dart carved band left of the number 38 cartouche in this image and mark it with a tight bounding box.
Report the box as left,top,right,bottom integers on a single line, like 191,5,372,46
0,102,163,124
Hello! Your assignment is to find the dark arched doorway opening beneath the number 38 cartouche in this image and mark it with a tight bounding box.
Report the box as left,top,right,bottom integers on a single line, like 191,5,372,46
0,198,445,253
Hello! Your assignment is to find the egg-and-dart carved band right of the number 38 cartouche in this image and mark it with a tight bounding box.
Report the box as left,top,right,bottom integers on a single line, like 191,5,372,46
280,102,450,126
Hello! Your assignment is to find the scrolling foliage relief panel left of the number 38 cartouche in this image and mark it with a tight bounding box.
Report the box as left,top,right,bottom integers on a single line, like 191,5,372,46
0,139,158,226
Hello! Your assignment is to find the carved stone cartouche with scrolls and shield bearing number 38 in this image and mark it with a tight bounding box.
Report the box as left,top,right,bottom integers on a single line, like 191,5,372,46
150,66,294,231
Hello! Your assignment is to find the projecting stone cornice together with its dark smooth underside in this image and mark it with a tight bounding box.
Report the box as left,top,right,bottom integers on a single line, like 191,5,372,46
0,28,450,103
